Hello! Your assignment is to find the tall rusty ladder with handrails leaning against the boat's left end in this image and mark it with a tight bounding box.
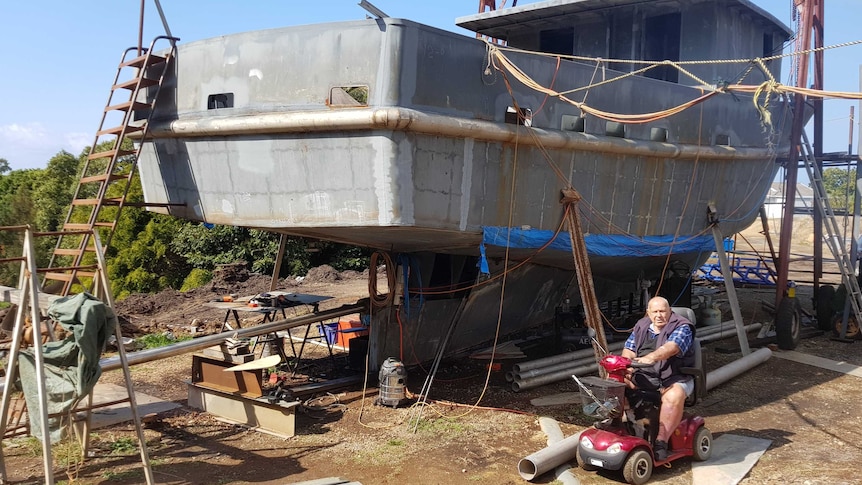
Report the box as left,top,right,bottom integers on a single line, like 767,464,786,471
42,36,179,295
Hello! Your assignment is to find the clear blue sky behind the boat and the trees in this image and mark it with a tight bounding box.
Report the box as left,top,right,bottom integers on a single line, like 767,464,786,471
0,0,862,169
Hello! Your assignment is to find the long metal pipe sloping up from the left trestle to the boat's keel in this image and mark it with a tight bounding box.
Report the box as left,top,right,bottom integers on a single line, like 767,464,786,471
99,304,367,371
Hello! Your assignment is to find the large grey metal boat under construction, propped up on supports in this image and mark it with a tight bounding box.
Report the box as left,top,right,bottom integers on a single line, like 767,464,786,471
139,0,791,363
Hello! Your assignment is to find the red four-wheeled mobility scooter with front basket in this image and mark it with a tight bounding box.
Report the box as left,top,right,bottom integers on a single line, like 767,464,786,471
572,339,712,485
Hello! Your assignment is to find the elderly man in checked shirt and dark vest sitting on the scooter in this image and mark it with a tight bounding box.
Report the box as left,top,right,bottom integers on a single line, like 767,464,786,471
622,297,694,461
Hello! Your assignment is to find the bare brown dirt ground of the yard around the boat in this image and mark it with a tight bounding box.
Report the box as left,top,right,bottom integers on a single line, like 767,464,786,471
4,224,862,485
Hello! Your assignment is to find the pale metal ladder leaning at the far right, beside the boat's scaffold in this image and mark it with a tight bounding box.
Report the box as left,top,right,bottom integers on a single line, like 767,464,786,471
800,131,862,328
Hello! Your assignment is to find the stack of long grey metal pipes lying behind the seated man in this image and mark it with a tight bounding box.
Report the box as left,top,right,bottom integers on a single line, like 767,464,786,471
506,322,760,392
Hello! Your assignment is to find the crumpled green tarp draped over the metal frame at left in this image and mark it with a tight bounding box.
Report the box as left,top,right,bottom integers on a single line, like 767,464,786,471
18,293,117,442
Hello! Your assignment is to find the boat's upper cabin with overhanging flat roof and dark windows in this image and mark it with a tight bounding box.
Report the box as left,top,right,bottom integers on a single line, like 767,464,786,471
456,0,792,84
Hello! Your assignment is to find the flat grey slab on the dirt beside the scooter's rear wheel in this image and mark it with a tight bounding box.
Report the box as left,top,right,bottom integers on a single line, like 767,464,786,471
691,434,772,485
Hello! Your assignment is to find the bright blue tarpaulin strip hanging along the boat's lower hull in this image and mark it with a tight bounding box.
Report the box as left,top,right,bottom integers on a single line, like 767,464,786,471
480,227,715,273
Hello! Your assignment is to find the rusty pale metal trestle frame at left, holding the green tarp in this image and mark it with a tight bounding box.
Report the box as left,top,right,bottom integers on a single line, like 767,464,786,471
0,226,155,485
